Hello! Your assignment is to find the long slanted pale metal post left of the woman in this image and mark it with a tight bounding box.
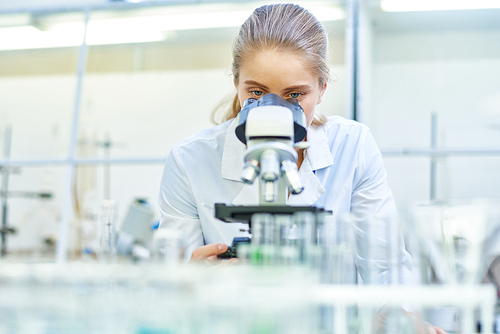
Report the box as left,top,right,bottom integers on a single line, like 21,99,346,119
56,8,90,264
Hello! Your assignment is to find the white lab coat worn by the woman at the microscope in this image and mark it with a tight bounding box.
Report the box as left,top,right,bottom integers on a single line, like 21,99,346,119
159,116,410,281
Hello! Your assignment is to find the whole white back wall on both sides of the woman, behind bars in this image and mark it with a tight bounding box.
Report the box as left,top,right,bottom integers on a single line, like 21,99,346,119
0,26,500,248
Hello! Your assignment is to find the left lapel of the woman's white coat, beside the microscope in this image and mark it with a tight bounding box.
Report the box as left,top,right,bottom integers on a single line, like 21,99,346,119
221,120,259,205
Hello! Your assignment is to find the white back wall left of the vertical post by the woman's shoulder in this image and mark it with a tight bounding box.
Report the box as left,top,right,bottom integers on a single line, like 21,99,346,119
0,66,345,250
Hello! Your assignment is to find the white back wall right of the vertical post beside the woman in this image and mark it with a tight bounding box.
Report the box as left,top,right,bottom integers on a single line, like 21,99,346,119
369,30,500,207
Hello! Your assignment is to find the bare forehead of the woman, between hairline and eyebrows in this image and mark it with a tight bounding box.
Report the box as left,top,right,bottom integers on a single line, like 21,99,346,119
240,50,319,85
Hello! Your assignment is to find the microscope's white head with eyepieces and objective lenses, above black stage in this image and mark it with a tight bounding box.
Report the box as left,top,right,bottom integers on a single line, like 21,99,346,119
236,94,307,205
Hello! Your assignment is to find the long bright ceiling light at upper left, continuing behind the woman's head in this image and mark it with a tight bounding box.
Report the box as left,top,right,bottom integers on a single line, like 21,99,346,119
0,3,344,50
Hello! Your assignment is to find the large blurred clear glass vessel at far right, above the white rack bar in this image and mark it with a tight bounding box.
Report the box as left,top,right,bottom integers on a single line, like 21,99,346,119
410,200,500,284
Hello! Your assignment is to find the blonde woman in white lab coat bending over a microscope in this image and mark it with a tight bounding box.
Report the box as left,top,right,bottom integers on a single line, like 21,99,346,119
159,4,409,276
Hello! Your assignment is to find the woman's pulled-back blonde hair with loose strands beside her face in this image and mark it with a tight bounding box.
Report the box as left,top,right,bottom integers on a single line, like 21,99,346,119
212,4,329,126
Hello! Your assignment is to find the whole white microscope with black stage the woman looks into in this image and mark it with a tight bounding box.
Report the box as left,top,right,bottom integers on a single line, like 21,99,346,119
215,94,323,258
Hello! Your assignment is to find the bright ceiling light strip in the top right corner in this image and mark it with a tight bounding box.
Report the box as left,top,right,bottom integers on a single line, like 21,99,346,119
380,0,500,12
